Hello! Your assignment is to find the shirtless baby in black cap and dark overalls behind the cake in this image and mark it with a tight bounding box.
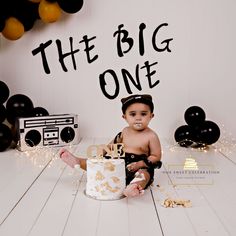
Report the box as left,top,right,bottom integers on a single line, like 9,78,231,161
59,94,162,197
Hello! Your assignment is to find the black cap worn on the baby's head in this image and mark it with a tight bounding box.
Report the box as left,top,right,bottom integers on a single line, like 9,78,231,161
121,94,154,114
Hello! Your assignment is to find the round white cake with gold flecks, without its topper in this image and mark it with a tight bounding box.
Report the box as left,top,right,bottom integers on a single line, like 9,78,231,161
86,158,125,200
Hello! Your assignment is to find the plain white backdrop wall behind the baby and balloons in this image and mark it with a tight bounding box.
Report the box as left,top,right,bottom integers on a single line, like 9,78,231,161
0,0,236,138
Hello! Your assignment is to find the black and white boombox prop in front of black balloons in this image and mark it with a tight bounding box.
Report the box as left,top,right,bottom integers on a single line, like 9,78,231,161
17,114,80,151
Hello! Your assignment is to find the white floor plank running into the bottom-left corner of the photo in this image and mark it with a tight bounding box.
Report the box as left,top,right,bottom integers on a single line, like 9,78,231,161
0,157,64,235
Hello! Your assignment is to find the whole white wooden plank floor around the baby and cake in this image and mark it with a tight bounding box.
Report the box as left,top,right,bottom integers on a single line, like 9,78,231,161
0,136,236,236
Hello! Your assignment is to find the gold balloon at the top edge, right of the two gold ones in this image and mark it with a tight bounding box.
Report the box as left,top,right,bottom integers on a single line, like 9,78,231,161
38,0,61,23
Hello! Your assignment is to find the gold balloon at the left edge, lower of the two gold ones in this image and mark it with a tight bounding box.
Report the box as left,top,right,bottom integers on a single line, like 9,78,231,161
2,17,25,40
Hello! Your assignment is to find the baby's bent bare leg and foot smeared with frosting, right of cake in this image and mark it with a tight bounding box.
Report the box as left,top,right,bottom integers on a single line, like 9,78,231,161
123,169,150,197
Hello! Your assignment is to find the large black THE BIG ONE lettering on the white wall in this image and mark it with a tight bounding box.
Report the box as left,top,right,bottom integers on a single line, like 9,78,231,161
32,22,173,99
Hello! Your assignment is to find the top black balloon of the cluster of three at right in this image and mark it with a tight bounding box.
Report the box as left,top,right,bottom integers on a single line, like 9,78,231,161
184,106,206,126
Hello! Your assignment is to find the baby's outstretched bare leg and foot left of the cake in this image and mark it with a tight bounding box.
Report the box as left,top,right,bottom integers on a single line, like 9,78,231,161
59,148,86,170
